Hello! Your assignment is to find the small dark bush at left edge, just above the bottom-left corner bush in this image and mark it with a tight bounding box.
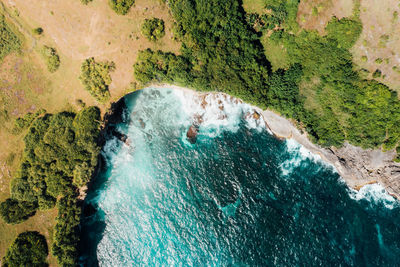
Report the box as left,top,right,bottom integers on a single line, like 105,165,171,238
0,198,38,224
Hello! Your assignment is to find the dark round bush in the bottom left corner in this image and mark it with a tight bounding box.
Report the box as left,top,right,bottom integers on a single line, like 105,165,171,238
2,232,49,267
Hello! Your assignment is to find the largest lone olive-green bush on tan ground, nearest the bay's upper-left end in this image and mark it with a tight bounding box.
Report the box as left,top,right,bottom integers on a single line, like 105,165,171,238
80,58,115,102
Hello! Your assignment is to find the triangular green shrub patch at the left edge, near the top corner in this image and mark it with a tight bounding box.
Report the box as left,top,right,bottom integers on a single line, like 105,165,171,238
0,15,21,60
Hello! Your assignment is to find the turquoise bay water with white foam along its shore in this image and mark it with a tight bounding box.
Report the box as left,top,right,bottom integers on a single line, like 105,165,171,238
81,88,400,266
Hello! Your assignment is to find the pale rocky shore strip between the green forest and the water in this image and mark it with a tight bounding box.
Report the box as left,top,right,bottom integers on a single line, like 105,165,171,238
146,84,400,199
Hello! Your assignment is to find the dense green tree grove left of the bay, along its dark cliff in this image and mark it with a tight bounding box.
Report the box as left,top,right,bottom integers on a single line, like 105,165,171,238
0,107,100,266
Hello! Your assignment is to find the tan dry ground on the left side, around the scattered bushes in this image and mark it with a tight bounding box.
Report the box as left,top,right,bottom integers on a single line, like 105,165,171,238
0,0,180,266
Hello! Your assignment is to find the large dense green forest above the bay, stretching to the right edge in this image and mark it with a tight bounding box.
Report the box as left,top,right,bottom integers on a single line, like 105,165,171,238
134,0,400,160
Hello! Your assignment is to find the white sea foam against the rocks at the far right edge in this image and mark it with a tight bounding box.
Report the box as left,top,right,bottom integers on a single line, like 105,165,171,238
349,183,399,209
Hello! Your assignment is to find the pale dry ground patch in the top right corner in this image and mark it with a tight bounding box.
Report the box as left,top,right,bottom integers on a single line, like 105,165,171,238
352,0,400,94
